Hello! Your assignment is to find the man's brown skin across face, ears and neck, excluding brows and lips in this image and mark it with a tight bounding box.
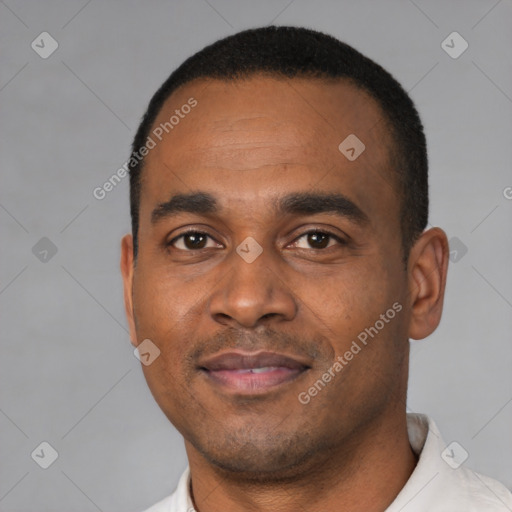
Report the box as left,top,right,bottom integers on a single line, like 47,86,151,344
121,76,448,512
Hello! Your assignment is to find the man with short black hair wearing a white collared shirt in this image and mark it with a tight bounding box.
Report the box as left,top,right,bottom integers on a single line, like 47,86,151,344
121,26,512,512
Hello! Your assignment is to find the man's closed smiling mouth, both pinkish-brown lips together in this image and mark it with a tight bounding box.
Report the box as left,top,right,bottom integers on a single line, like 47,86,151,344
199,352,311,395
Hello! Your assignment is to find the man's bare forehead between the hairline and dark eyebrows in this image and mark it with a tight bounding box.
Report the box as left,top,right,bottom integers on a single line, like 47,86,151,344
141,76,396,226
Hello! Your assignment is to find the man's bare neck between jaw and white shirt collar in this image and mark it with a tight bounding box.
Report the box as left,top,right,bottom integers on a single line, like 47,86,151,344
185,411,417,512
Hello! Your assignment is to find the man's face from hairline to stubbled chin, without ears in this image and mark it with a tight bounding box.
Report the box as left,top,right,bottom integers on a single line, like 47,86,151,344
126,76,409,476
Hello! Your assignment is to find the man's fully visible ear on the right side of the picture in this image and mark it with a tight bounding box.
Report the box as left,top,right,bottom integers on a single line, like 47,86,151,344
408,228,450,340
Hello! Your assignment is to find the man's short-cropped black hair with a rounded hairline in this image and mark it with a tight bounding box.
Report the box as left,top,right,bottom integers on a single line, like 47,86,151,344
129,25,428,263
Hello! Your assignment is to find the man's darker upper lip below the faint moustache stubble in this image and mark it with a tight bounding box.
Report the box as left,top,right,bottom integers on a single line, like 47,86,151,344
199,352,310,371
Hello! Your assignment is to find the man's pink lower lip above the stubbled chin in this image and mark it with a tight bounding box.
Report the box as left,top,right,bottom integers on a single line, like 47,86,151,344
205,366,304,394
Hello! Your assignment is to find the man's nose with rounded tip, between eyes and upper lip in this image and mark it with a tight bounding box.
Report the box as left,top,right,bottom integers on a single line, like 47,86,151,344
209,251,297,328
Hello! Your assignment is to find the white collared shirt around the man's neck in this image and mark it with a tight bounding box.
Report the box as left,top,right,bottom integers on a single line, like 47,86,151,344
145,414,512,512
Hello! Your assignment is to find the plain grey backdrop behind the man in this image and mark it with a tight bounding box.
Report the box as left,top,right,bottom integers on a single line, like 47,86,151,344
0,0,512,512
